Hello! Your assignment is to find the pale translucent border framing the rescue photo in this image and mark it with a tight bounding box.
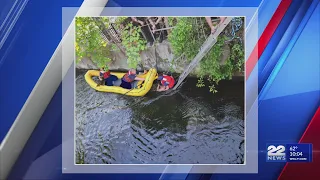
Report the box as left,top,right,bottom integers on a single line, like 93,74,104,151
62,7,258,173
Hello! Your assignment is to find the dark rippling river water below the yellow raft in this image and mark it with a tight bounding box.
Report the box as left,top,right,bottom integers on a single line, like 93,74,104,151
76,73,244,164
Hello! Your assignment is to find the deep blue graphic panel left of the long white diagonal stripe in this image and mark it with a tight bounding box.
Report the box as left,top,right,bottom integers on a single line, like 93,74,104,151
0,0,83,142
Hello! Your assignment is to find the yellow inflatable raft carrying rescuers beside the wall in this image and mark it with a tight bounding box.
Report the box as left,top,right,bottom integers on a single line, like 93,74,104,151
84,69,157,96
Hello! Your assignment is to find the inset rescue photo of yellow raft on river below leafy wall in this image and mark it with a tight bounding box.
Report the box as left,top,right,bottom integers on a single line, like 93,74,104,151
75,17,245,164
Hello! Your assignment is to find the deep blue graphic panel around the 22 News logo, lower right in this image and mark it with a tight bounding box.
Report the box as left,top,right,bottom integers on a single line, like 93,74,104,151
211,91,320,180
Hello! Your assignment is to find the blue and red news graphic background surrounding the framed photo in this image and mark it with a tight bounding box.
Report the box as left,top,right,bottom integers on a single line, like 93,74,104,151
0,0,320,179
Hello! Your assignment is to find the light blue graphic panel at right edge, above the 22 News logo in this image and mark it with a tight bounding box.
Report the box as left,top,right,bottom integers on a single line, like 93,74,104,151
265,1,320,99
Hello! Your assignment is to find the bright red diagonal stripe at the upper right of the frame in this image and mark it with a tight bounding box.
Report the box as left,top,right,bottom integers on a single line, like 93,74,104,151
246,0,292,80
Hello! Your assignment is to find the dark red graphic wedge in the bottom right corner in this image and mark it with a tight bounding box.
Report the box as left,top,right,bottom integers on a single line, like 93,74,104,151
278,107,320,180
